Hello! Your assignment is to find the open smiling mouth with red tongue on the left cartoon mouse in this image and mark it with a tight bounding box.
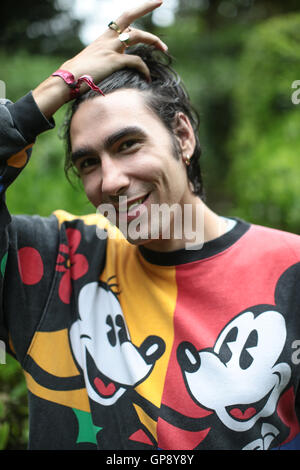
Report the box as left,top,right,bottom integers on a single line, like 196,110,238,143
86,349,121,398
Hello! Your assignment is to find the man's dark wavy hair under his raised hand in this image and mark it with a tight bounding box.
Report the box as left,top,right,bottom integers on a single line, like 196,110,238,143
61,45,204,199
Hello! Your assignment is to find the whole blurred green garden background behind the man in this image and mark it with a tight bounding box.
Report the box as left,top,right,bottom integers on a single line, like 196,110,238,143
0,0,300,450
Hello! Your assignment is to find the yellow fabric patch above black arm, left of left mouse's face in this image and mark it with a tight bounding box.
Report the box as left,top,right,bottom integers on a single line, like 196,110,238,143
28,328,79,377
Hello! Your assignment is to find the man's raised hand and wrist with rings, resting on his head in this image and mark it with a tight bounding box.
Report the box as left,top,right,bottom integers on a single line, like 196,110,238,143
33,0,167,118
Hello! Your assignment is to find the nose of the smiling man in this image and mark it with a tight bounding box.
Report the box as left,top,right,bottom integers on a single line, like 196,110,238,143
101,156,130,196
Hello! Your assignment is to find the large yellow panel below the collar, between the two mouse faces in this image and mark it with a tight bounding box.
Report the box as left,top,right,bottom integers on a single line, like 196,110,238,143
101,240,177,407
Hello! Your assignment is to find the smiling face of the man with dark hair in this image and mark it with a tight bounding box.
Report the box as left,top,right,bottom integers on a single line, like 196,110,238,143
70,90,191,243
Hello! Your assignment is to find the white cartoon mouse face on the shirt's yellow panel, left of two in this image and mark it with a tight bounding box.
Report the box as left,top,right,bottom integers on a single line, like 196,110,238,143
69,279,165,406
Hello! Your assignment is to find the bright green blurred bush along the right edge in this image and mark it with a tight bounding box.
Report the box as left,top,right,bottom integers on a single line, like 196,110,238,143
228,15,300,233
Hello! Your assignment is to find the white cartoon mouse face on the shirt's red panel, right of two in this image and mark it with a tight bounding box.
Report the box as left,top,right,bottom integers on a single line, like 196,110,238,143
178,310,291,431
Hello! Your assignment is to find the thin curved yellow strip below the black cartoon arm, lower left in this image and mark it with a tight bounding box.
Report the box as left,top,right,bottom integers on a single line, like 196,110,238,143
24,371,90,412
